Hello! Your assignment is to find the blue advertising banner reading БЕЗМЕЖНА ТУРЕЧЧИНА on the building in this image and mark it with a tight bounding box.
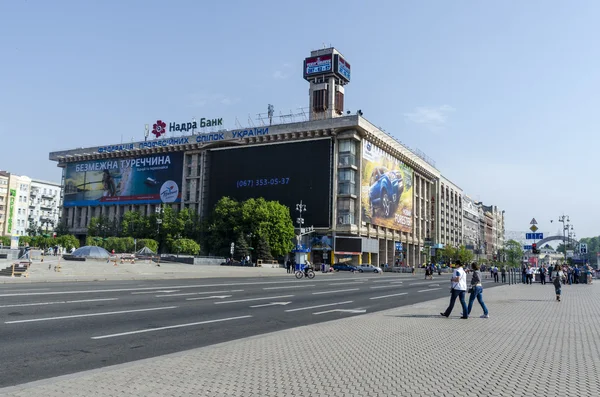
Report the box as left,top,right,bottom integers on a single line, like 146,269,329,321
63,153,183,207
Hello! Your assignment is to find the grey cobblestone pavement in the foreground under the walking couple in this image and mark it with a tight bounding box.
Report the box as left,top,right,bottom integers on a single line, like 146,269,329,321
0,282,600,397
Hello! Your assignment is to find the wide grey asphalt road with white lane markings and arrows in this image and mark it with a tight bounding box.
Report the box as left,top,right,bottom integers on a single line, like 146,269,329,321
0,273,506,387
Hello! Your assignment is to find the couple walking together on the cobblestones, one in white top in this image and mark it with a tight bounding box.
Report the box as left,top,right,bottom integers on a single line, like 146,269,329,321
440,261,489,319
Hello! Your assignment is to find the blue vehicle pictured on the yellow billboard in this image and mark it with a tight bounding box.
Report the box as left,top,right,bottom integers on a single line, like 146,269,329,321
369,167,404,218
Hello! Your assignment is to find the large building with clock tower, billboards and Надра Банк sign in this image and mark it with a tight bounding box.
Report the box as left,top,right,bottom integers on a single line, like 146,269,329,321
50,48,504,265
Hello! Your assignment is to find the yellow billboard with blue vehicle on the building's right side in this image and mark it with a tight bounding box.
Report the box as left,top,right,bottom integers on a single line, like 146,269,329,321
361,142,414,232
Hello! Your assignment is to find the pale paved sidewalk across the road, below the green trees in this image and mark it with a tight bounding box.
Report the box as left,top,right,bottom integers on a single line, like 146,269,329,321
0,256,286,284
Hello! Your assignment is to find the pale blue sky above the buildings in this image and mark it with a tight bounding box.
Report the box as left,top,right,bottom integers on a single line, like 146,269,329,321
0,0,600,237
